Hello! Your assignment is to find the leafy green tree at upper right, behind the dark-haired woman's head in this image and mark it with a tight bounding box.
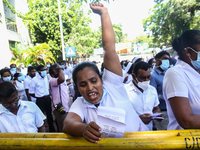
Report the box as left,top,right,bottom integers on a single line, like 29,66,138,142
143,0,200,47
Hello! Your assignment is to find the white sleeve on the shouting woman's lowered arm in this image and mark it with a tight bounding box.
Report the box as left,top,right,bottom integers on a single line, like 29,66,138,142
69,97,85,122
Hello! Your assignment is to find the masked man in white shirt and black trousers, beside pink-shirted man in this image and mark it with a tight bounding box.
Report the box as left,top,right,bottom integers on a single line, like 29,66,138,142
29,65,55,132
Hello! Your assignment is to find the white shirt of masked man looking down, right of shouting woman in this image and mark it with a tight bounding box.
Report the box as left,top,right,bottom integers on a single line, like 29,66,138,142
125,82,159,131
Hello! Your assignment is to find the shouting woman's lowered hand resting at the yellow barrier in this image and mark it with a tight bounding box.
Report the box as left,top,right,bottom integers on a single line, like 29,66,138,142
83,121,102,143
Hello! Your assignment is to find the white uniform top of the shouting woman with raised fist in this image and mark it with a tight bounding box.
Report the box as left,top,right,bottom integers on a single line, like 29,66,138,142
69,69,148,132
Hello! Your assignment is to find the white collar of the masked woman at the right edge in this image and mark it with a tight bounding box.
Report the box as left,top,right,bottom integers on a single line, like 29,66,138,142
175,59,200,86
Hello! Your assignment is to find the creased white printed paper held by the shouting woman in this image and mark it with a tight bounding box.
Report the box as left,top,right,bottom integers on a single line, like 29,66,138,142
97,106,126,138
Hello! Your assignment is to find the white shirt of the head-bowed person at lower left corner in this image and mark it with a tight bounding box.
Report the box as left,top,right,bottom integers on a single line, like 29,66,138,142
0,101,46,133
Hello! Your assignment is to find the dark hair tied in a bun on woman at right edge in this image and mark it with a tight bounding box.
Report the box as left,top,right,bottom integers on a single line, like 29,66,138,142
172,30,200,60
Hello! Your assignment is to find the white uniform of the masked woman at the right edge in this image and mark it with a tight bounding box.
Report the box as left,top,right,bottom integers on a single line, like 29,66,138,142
163,59,200,130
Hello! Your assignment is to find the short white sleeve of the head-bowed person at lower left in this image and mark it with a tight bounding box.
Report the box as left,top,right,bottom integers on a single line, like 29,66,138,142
33,103,46,128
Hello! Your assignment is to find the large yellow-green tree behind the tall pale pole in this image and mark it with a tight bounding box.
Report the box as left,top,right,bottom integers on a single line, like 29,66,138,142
24,0,104,61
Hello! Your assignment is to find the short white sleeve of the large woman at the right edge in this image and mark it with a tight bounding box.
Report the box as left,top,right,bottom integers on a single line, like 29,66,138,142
163,67,188,99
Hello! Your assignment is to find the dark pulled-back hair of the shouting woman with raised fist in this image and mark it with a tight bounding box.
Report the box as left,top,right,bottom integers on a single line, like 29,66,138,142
72,61,101,99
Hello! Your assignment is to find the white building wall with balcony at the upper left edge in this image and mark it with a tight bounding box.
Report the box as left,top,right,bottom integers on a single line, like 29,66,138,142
0,0,30,69
